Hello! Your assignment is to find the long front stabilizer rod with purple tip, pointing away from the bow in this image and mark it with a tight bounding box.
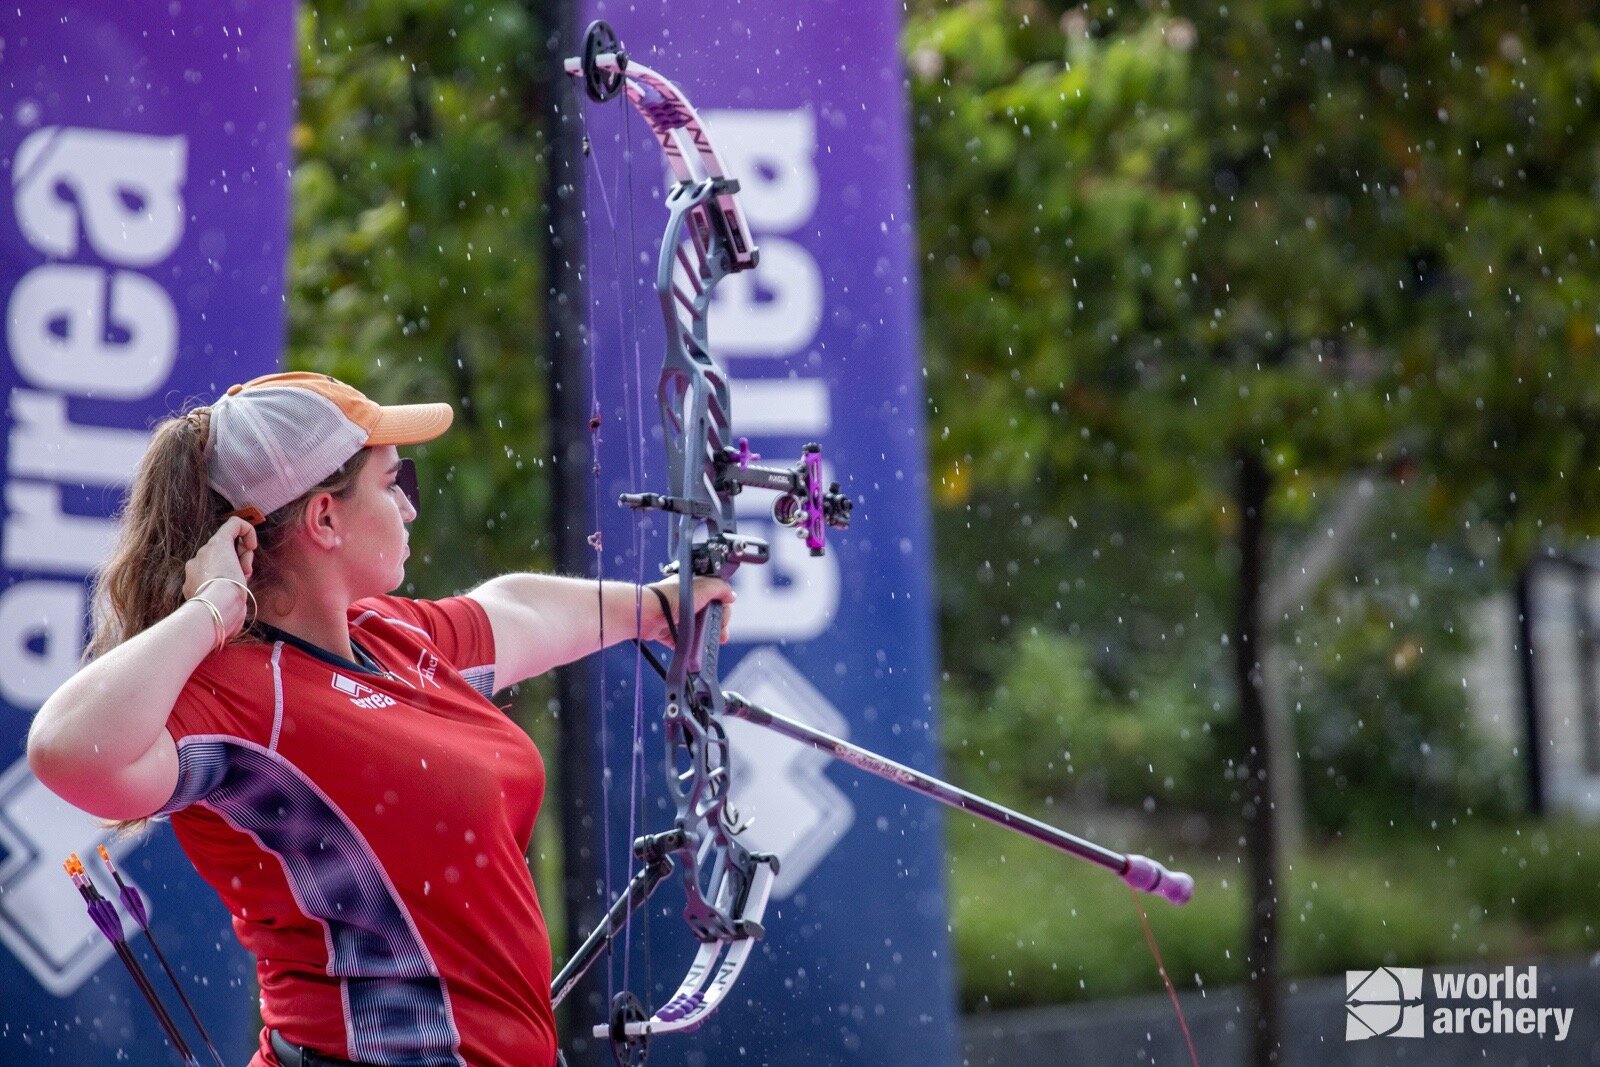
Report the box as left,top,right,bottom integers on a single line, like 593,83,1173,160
722,693,1195,904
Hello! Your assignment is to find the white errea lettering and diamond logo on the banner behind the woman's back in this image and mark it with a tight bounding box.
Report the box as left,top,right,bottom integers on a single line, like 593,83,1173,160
0,119,189,997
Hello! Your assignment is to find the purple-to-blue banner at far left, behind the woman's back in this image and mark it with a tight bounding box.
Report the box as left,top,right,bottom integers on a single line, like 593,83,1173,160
0,0,294,1064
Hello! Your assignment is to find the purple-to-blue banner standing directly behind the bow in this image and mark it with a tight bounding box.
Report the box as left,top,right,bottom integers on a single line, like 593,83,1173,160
566,0,957,1067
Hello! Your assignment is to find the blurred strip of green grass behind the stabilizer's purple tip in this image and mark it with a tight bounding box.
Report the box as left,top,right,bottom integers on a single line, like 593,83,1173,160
949,819,1600,1009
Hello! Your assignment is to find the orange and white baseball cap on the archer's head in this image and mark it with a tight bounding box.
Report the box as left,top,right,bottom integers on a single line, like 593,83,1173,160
206,371,456,522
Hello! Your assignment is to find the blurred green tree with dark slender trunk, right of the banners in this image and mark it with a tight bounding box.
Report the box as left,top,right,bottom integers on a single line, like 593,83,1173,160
907,0,1600,1062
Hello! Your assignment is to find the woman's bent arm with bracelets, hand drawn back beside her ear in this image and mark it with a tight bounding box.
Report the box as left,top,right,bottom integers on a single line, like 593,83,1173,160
27,518,256,819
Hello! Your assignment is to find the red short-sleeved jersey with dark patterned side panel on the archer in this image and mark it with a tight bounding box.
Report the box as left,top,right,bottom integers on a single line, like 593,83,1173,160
162,597,555,1067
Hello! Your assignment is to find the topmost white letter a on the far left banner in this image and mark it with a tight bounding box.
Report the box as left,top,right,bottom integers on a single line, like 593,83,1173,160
11,126,189,267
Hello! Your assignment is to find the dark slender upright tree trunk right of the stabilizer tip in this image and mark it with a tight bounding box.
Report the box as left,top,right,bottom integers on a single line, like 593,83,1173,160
1232,448,1282,1067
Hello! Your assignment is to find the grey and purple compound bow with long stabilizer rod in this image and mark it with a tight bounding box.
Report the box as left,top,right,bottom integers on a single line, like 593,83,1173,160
552,21,1194,1065
